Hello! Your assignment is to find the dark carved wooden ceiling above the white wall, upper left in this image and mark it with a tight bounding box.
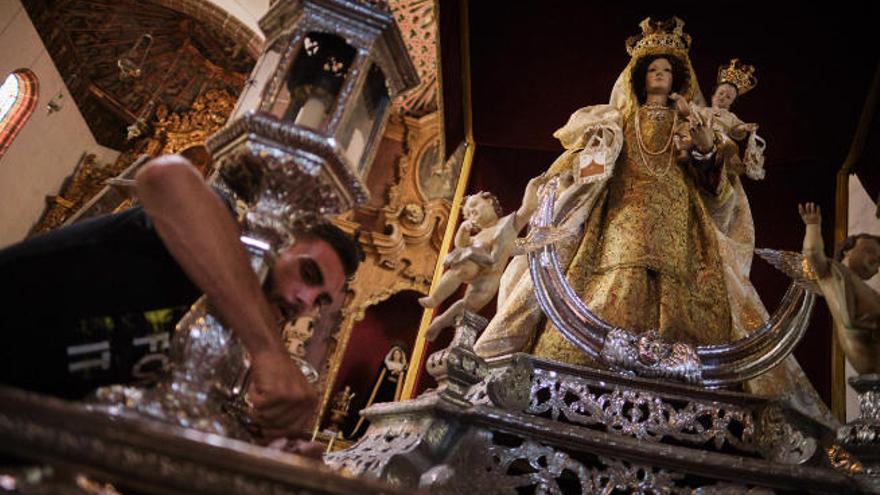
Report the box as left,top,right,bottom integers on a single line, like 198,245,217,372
24,0,254,149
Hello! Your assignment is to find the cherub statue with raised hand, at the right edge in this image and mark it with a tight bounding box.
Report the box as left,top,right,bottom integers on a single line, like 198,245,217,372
798,203,880,374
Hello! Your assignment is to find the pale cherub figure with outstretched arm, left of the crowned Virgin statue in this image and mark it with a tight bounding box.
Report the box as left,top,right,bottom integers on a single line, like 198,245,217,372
419,176,545,341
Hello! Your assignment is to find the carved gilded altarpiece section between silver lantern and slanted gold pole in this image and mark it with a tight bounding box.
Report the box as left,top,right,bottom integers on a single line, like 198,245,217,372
314,112,460,436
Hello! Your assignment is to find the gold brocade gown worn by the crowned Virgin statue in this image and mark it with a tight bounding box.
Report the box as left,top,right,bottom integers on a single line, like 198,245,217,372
533,107,732,365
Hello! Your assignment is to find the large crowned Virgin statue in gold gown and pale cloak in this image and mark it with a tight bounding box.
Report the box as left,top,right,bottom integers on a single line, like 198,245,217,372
476,18,827,415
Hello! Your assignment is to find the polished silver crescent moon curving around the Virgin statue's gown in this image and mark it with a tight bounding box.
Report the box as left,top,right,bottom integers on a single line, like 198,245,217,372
528,179,815,388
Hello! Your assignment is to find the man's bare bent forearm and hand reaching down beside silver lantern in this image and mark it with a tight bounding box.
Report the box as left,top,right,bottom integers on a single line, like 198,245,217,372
136,156,315,436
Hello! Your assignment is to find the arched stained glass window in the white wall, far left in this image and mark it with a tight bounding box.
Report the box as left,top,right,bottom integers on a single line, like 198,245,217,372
0,69,39,157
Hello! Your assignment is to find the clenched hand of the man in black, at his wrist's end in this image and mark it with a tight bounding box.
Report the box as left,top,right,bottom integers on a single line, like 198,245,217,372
248,352,317,440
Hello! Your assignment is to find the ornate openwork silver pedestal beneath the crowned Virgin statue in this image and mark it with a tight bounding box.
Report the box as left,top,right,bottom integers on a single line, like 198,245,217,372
325,346,870,495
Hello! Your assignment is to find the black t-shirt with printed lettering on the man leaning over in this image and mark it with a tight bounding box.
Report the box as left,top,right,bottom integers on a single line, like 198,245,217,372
0,192,229,397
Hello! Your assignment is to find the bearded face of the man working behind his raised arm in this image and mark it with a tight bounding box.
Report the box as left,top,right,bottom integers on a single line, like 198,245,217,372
268,239,345,319
